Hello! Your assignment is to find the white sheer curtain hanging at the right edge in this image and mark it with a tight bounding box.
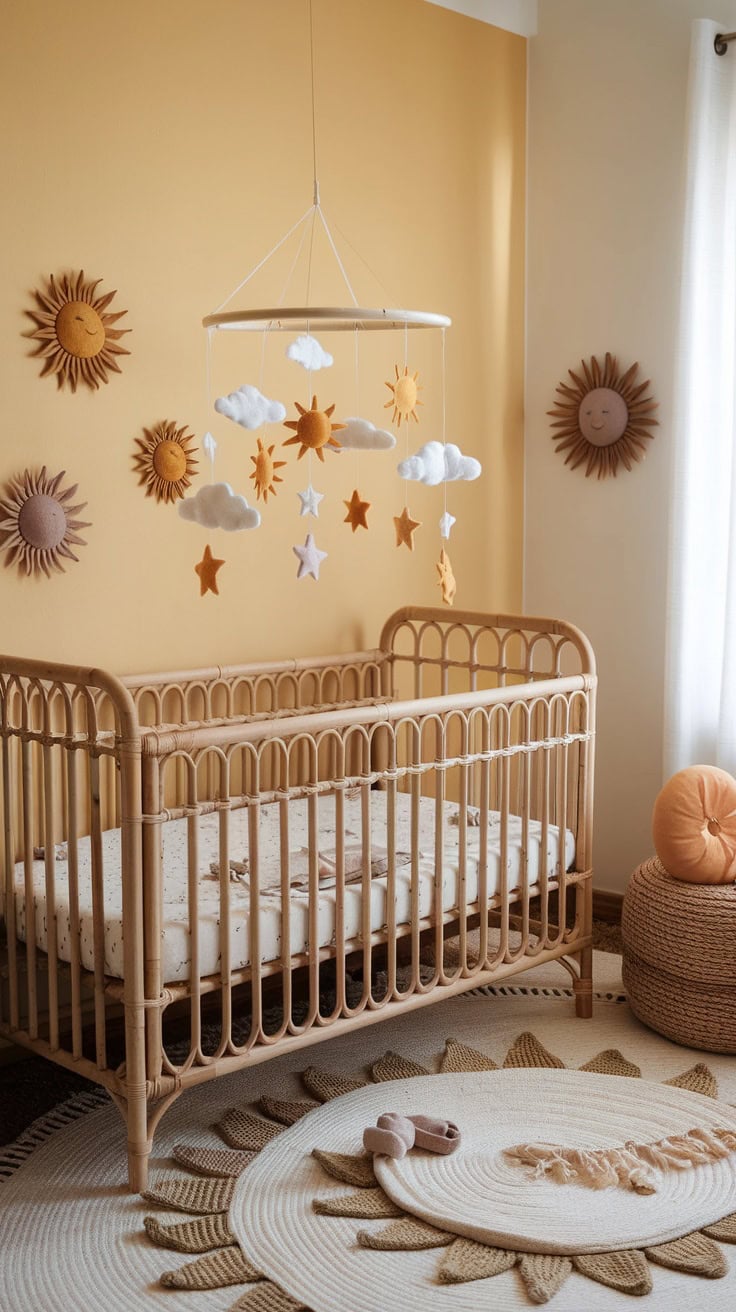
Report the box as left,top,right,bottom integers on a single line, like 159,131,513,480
664,21,736,777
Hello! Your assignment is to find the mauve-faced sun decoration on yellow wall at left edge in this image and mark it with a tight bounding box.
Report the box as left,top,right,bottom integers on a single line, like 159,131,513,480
0,466,89,579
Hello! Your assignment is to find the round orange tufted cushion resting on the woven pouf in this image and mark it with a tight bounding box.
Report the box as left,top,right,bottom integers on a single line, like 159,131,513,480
652,765,736,884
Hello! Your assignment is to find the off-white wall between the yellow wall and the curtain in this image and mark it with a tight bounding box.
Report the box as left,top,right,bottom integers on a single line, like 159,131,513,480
525,0,736,891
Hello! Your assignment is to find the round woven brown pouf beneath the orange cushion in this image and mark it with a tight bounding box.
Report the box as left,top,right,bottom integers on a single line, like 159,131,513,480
622,857,736,1052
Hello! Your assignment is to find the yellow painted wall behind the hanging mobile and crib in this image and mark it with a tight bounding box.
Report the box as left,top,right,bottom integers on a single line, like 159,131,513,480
0,0,525,672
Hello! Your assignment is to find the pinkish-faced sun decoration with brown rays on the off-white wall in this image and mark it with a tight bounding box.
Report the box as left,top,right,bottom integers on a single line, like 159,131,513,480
547,352,659,479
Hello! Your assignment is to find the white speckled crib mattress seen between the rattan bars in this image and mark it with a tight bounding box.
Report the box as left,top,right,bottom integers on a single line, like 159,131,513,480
14,791,575,984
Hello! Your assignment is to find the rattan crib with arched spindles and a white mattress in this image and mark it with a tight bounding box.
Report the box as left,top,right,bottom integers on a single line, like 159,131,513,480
0,607,596,1190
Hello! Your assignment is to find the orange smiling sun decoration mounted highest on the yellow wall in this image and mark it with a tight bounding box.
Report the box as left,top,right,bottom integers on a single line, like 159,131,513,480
26,270,130,392
